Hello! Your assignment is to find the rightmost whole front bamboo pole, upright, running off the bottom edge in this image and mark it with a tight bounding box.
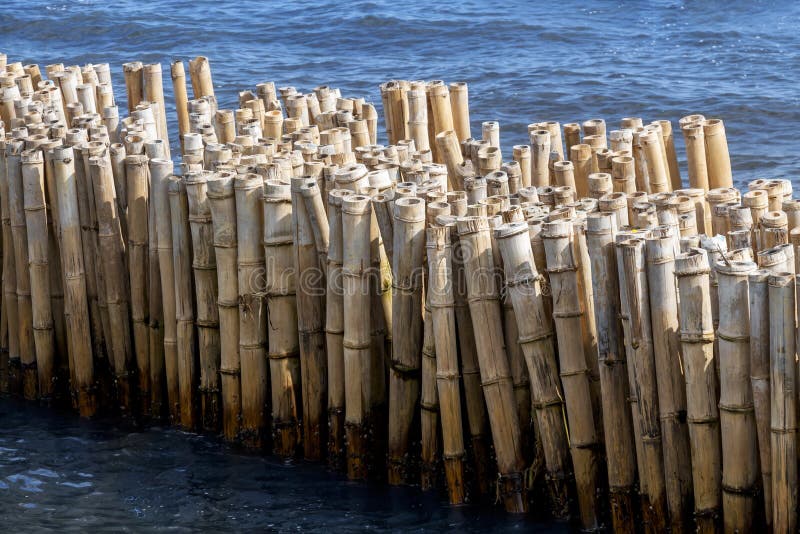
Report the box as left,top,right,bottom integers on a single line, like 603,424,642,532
768,272,798,532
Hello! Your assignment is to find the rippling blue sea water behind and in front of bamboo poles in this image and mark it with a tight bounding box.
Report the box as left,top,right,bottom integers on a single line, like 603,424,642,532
0,0,800,530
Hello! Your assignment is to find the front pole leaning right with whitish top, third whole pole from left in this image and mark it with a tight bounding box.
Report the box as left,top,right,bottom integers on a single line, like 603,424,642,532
51,147,98,417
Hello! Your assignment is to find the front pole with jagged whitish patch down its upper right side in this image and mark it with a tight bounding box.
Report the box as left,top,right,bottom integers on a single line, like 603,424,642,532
675,248,722,532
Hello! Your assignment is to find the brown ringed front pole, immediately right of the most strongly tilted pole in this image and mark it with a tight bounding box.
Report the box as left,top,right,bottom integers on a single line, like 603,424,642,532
542,219,599,528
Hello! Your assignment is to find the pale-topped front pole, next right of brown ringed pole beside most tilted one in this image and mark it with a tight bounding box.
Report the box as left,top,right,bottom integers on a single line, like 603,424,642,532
584,213,636,532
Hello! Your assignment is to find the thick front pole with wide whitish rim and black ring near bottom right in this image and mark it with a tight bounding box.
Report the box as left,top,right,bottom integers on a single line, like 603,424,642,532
715,261,759,532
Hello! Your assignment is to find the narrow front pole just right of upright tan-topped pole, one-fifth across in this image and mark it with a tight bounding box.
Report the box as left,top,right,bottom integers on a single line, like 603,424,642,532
150,158,180,423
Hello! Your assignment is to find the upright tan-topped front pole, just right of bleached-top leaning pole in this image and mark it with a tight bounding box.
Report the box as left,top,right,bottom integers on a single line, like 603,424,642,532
125,155,153,415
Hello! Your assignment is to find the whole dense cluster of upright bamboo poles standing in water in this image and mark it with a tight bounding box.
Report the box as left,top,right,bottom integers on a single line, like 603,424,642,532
0,51,800,532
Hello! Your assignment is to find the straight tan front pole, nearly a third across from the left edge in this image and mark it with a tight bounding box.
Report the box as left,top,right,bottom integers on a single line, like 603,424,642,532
233,174,269,448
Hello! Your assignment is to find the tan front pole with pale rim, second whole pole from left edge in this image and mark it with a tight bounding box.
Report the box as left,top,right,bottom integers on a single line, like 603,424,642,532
21,149,56,402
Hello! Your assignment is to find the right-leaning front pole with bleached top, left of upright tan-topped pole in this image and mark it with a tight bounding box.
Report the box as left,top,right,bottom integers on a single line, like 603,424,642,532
88,153,135,417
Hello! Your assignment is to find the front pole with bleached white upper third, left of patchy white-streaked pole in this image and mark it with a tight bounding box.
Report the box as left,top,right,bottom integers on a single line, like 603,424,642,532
646,226,692,531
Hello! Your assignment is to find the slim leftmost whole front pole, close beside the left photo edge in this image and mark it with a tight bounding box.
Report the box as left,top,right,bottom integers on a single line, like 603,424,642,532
6,140,39,400
